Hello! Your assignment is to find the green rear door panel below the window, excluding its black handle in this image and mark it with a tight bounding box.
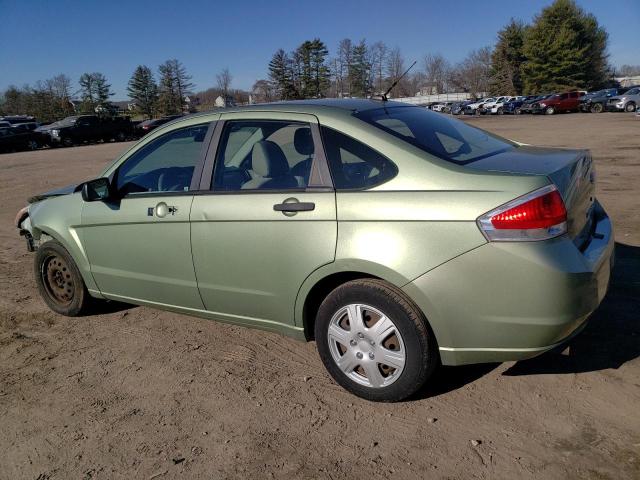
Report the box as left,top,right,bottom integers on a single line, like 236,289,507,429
191,191,337,326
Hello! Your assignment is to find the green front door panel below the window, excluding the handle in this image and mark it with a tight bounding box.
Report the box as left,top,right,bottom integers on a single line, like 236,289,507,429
80,195,204,309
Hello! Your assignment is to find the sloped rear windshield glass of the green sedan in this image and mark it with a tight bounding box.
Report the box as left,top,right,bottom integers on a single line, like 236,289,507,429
354,107,515,165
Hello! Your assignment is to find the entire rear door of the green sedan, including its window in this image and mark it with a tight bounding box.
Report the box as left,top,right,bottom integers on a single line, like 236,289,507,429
191,112,337,329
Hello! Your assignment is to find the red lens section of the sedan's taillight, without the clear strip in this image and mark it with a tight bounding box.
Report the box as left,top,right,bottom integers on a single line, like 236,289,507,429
491,190,567,230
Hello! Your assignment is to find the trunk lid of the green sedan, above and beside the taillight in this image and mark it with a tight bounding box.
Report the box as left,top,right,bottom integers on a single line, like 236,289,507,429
466,145,595,248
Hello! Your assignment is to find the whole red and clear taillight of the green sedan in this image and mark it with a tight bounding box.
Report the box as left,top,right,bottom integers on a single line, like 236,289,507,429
477,185,567,242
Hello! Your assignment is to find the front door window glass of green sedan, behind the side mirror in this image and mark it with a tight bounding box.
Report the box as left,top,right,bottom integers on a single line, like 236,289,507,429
116,123,209,195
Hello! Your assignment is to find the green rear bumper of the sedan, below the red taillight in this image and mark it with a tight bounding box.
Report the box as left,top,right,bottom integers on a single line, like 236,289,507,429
403,201,614,365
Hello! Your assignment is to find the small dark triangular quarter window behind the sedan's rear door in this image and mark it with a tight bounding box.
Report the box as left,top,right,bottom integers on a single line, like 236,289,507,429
321,127,398,190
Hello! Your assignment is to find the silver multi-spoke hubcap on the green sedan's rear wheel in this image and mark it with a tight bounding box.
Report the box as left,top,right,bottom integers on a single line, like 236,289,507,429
327,304,406,388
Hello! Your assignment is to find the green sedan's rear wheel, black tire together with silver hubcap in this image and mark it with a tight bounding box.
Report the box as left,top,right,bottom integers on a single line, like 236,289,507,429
315,279,440,402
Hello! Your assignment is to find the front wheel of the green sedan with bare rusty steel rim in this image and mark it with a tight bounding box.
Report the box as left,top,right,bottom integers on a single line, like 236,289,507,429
34,240,92,317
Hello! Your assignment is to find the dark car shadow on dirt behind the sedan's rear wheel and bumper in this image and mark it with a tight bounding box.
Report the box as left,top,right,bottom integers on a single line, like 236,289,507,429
408,243,640,401
